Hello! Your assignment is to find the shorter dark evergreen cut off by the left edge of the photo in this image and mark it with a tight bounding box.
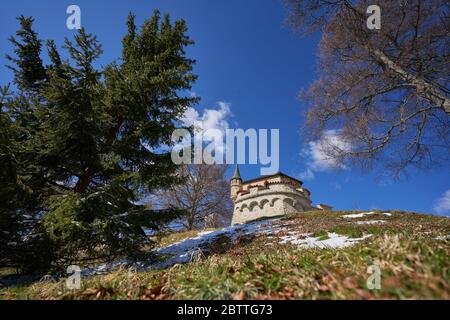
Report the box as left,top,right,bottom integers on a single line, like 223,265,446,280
0,88,53,273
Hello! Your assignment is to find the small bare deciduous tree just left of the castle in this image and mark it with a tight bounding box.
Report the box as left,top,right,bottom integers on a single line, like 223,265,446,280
155,164,232,230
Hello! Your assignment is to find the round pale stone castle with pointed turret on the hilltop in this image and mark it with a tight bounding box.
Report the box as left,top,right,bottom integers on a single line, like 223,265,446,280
230,166,331,224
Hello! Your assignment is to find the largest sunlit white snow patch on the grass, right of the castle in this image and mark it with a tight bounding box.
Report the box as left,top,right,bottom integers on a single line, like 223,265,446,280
281,232,372,249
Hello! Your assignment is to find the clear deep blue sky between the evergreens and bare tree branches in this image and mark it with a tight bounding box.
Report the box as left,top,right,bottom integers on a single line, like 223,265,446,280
0,0,450,215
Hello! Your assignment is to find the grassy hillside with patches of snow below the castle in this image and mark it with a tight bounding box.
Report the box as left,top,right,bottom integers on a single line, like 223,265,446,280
0,211,450,299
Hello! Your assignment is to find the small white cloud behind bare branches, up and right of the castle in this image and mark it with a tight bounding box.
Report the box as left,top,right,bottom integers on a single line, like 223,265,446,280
300,130,352,180
